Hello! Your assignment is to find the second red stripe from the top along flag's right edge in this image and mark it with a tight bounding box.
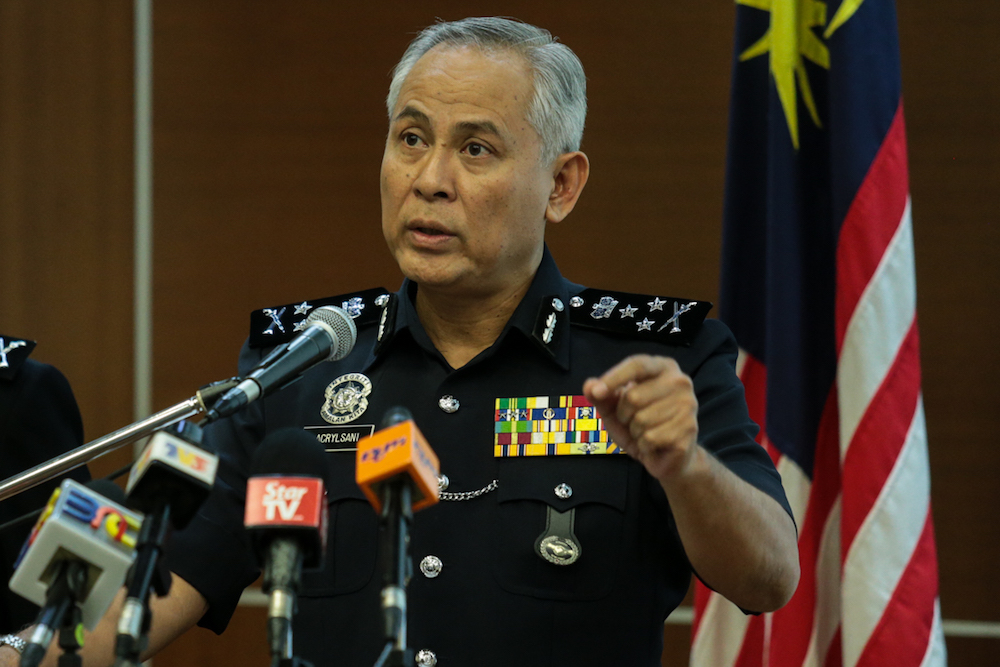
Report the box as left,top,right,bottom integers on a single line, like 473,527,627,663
841,319,920,558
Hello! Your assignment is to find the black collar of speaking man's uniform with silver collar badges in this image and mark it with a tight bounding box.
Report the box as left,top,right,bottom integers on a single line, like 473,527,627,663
365,246,583,369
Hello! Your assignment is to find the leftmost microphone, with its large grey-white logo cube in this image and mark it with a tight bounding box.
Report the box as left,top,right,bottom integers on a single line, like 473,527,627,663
10,479,142,667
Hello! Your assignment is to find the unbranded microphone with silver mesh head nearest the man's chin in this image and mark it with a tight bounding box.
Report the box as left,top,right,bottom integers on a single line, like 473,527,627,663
206,306,358,421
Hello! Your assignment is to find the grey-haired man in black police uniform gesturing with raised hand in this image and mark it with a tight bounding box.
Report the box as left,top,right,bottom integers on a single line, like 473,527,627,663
0,19,799,667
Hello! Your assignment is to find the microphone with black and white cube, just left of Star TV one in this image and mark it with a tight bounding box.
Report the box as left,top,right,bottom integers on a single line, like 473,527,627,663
115,421,219,667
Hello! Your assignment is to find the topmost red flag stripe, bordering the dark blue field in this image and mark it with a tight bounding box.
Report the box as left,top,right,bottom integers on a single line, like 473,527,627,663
836,101,909,356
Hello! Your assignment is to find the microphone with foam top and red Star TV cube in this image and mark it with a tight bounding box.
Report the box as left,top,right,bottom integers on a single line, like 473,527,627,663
243,428,328,664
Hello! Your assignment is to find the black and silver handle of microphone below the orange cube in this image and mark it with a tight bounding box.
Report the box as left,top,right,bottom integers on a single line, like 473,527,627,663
375,481,415,667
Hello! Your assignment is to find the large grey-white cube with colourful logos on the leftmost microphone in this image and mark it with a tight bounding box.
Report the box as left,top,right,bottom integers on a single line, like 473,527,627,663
10,479,143,630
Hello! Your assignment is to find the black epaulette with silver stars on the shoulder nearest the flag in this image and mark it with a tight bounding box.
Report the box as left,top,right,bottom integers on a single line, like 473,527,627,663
569,289,712,346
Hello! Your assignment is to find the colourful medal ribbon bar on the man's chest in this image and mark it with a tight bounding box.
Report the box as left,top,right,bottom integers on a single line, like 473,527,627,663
493,396,624,458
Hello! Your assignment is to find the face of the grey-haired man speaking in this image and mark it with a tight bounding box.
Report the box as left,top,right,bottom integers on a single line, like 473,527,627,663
381,46,554,296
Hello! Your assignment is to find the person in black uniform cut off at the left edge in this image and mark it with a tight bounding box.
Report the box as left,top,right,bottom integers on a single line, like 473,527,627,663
0,336,90,645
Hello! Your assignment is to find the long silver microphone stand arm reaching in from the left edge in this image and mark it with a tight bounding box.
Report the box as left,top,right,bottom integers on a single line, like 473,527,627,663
0,378,239,500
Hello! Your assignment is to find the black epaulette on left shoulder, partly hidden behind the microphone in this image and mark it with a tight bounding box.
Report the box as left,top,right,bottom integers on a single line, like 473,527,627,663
250,287,390,348
